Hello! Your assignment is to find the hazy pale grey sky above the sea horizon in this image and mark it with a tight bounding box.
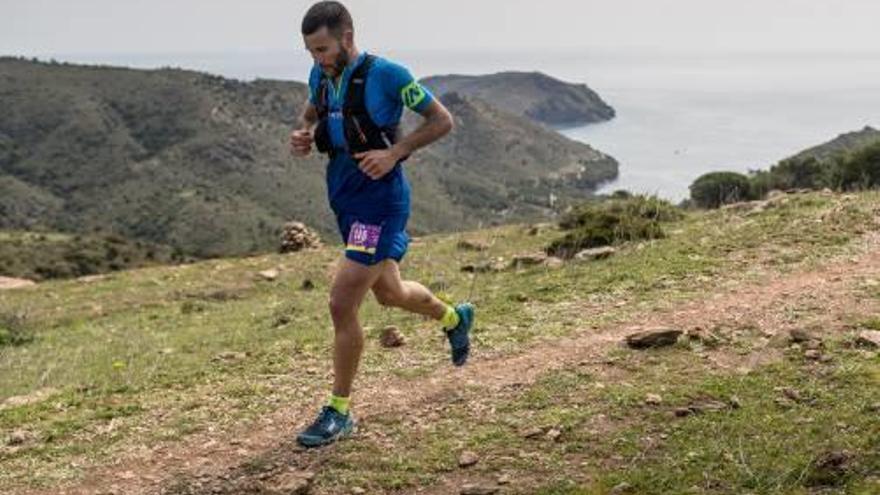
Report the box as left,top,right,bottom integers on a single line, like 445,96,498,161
0,0,880,55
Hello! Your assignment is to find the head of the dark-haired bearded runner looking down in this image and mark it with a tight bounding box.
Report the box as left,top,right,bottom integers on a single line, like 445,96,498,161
302,2,354,77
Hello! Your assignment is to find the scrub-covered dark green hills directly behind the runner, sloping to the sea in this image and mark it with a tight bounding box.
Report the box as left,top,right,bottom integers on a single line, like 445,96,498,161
0,58,617,257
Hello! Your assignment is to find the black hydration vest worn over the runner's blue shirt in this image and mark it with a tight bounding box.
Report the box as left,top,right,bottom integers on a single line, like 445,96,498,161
315,54,398,158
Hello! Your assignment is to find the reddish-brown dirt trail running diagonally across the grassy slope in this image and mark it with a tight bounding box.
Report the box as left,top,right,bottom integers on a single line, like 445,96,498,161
20,233,880,495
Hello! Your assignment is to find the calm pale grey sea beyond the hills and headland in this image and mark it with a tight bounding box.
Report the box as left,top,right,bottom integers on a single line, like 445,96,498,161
56,50,880,201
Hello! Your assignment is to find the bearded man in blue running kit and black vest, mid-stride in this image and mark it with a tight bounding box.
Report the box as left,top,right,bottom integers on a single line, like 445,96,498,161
290,1,474,447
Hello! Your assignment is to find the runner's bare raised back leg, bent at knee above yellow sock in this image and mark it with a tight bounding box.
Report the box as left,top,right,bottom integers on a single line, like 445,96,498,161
372,260,446,320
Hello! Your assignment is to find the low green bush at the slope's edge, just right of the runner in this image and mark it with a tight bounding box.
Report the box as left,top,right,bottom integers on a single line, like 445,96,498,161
546,195,684,258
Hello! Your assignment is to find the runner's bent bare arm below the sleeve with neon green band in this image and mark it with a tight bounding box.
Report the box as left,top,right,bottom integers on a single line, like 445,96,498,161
354,82,453,179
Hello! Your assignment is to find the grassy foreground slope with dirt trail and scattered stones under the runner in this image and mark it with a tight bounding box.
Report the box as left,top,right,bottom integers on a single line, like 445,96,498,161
0,192,880,494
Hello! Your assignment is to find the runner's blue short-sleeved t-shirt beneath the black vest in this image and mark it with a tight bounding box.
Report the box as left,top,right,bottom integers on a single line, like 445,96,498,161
309,53,434,215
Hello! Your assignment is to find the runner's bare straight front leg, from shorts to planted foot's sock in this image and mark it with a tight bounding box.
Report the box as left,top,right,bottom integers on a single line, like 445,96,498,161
330,258,383,397
